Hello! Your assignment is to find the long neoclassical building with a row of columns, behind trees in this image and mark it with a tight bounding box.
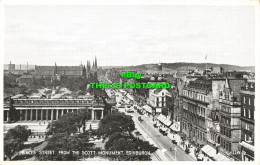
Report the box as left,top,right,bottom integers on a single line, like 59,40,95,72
4,96,104,122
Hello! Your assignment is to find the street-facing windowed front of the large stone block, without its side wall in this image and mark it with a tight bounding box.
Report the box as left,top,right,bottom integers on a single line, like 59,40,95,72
181,80,212,145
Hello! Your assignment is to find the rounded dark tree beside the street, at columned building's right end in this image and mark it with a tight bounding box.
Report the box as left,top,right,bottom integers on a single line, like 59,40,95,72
97,112,135,135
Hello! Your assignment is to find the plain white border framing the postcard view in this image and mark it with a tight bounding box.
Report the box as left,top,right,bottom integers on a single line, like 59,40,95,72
0,0,260,165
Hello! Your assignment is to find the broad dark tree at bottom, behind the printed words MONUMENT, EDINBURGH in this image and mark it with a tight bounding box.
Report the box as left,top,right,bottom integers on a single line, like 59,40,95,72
105,132,157,160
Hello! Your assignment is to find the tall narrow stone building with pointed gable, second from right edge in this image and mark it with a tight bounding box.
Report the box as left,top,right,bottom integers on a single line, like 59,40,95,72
219,79,245,159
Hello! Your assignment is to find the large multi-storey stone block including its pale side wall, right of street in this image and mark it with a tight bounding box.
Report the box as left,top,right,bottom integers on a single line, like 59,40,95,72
181,78,225,146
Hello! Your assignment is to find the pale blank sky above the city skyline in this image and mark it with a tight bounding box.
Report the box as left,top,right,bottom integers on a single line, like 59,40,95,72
4,5,255,66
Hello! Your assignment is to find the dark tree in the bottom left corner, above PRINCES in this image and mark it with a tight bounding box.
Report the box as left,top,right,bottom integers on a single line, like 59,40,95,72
4,125,31,160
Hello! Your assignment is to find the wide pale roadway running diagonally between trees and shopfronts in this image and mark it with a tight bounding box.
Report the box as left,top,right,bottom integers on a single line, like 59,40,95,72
116,89,194,161
